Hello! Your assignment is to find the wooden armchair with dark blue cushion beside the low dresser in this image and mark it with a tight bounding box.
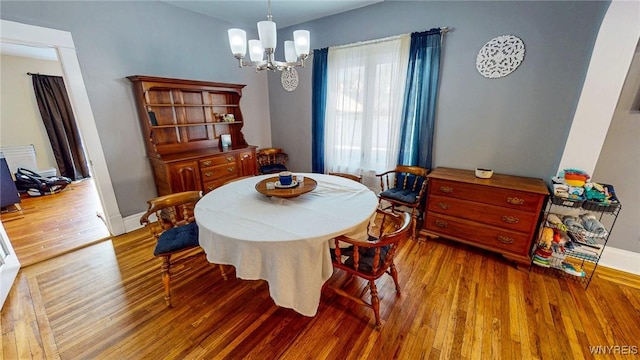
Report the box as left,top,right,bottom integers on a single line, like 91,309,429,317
376,165,429,239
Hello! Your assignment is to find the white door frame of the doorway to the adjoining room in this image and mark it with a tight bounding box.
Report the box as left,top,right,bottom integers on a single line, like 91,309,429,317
0,19,125,235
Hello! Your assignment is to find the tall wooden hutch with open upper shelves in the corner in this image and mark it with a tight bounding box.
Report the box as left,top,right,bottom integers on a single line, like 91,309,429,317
127,75,257,195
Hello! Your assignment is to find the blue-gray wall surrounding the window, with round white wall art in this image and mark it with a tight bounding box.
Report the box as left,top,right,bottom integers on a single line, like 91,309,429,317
269,1,609,179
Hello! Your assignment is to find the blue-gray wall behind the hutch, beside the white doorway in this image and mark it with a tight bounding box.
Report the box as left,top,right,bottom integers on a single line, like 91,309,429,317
0,1,271,216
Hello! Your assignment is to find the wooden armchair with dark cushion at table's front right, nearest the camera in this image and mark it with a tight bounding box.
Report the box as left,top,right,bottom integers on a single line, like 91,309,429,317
331,209,411,329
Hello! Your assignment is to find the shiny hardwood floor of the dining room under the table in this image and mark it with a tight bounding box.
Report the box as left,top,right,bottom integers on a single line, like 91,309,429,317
0,224,640,359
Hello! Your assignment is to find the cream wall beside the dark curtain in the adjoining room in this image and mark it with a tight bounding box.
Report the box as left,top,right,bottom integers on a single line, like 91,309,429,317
0,55,62,173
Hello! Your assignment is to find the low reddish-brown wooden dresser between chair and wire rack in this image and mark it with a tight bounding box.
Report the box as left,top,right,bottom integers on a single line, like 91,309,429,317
420,168,549,266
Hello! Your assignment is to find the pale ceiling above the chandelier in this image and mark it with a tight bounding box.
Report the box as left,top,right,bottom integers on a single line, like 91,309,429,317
163,0,384,29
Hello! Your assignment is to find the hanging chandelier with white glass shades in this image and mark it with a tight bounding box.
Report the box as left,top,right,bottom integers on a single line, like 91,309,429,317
228,0,310,72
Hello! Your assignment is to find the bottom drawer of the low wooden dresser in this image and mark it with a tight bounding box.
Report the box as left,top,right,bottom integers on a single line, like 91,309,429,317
424,212,531,255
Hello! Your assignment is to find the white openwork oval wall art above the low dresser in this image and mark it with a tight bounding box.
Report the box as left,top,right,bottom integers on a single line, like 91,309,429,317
476,35,524,79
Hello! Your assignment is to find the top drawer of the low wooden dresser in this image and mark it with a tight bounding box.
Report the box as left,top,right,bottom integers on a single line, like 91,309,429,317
429,179,544,212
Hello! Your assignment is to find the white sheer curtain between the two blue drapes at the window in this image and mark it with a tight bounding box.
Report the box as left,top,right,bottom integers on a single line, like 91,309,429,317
324,34,411,187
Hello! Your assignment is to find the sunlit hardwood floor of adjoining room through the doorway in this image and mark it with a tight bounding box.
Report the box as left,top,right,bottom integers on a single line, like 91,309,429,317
2,179,111,267
